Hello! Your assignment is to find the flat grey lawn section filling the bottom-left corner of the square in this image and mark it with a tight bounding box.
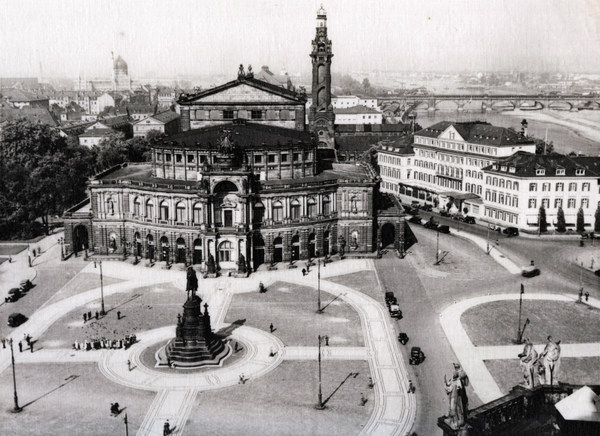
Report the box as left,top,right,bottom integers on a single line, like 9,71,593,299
0,363,155,436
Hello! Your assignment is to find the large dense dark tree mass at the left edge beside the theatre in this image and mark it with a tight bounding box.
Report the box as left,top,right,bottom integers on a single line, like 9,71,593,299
0,118,92,238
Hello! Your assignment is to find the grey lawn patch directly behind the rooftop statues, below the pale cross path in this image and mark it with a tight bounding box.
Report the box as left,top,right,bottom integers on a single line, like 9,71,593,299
485,357,600,394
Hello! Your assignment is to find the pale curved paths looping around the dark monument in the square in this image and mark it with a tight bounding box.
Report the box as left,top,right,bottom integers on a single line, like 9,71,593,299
0,260,416,435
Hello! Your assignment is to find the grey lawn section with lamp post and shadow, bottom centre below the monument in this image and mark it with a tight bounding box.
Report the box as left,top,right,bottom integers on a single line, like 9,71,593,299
184,360,373,436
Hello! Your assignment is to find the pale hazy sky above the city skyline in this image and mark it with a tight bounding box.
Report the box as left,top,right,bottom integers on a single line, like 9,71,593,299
0,0,600,79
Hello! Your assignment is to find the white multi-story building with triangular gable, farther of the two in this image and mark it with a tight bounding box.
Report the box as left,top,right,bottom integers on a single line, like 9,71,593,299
399,121,535,210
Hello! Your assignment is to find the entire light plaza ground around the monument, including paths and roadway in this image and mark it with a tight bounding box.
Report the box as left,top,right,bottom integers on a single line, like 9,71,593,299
0,228,600,435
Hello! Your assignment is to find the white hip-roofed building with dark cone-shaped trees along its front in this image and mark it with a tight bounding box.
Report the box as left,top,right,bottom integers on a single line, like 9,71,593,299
483,152,600,230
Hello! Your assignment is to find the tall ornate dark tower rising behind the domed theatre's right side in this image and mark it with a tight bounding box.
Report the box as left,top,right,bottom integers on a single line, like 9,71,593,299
308,5,335,149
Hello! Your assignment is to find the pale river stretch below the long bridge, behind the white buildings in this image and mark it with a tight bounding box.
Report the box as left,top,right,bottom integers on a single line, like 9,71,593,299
416,109,600,156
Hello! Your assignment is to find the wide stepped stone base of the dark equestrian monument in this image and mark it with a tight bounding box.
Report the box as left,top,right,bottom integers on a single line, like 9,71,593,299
155,338,232,369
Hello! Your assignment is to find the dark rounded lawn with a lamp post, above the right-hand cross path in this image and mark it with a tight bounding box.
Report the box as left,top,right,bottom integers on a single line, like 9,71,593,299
461,300,600,346
